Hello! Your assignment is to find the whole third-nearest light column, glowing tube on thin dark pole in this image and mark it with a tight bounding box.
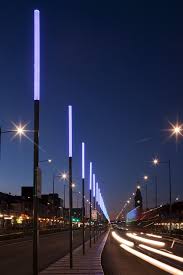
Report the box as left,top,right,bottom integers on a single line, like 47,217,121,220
82,142,85,255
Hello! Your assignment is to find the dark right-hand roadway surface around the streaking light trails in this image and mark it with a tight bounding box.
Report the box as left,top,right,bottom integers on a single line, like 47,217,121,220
102,230,183,275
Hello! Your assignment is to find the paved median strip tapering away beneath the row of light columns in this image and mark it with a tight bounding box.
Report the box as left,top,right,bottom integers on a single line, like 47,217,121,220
40,232,109,275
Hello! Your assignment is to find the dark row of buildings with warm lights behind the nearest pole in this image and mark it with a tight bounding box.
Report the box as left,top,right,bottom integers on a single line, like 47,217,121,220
0,189,63,228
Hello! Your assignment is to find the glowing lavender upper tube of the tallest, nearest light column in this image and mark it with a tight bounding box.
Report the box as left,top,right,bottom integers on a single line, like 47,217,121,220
34,10,40,100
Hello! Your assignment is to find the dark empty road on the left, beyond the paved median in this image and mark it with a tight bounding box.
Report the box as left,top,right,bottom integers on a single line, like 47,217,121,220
0,230,89,275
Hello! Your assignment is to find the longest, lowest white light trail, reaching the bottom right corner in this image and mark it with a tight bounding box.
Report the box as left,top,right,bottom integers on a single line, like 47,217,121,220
120,244,183,275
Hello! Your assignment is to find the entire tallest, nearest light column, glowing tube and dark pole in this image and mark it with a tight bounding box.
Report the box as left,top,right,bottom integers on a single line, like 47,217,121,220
33,10,40,275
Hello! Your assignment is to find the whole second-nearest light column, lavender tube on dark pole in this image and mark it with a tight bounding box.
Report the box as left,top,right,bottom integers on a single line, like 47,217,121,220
68,106,73,268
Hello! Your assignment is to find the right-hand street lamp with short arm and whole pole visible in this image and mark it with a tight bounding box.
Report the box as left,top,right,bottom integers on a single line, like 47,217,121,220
153,158,172,234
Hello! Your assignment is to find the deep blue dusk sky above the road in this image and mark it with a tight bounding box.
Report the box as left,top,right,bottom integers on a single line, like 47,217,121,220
0,0,183,220
